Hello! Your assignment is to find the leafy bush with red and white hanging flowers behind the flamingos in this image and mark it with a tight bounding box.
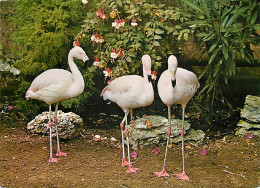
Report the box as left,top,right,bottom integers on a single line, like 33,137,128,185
76,0,191,79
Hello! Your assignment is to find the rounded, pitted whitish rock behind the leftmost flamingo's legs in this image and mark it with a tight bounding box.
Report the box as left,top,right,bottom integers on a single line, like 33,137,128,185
27,110,83,139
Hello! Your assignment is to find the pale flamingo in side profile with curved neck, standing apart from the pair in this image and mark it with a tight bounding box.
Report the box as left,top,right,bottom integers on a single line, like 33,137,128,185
25,46,89,163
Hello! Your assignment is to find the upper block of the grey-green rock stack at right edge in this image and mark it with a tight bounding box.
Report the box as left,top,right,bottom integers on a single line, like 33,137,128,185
241,95,260,123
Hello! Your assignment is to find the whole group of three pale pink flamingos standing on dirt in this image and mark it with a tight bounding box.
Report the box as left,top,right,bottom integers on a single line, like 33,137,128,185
26,43,199,180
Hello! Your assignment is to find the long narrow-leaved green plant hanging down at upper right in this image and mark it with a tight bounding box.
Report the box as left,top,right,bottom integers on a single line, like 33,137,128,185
183,0,259,122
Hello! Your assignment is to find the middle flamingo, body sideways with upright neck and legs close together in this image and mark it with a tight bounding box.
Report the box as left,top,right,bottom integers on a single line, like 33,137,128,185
100,55,154,173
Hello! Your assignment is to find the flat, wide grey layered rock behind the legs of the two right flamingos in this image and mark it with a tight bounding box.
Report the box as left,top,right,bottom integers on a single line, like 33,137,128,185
128,116,205,149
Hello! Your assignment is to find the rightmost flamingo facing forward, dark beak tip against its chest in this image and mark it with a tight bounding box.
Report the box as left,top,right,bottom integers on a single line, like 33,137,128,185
154,55,200,180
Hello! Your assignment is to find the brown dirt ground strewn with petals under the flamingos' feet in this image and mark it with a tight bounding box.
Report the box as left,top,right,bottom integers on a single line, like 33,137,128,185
0,117,260,188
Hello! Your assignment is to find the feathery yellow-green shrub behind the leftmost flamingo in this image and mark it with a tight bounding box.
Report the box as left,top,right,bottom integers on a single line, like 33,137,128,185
12,0,94,116
